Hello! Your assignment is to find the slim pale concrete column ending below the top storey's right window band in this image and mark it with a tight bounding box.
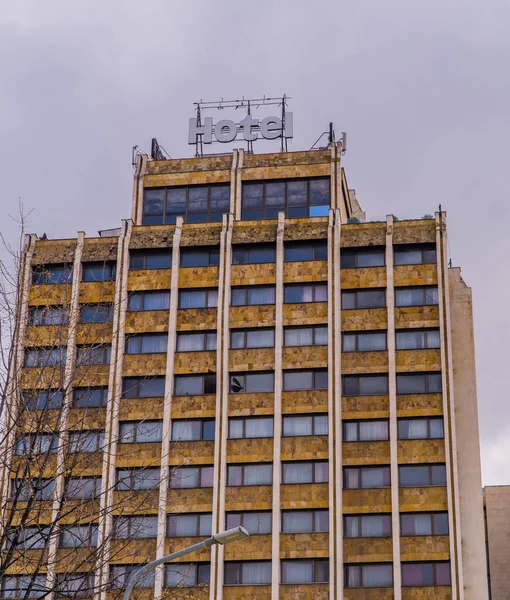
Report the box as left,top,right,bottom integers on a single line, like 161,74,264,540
271,213,285,600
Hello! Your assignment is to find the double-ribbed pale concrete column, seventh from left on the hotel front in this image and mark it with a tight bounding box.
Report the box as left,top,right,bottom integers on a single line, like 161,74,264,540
328,209,344,600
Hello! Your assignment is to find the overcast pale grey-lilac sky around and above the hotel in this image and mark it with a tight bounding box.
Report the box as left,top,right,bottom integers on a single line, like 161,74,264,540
0,0,510,484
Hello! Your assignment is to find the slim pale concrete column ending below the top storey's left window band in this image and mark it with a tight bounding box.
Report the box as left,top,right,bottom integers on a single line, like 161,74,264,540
154,217,182,598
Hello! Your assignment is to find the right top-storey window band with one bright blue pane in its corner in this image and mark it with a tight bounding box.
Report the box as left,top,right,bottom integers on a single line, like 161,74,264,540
242,177,330,220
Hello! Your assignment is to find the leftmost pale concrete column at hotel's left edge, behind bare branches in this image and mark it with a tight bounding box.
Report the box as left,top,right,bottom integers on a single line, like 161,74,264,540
0,235,37,524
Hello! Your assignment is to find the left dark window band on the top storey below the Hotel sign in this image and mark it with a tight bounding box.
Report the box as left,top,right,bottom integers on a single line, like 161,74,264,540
143,183,230,225
